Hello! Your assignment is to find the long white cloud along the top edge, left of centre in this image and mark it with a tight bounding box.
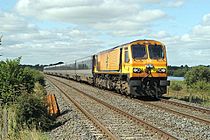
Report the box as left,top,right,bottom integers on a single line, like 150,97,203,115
16,0,134,24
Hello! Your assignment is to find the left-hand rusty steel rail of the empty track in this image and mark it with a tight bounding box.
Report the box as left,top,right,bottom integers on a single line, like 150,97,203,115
45,76,119,140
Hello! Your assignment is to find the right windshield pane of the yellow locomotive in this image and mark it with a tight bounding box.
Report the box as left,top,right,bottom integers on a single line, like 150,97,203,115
148,45,164,59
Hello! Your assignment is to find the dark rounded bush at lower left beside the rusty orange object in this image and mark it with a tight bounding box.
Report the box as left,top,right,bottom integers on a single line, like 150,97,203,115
16,94,53,130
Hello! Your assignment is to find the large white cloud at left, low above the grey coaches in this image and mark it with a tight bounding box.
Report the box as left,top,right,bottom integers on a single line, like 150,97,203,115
0,9,104,64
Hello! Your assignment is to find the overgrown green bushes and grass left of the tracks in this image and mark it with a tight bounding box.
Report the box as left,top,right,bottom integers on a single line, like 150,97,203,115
0,58,53,139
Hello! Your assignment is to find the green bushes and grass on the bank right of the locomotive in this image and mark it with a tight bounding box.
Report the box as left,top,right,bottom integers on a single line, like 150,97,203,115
169,66,210,106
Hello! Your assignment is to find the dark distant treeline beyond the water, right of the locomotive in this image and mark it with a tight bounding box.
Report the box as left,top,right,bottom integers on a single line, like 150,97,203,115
168,65,210,77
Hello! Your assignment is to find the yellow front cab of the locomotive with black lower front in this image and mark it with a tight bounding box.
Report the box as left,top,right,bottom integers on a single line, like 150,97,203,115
122,40,168,97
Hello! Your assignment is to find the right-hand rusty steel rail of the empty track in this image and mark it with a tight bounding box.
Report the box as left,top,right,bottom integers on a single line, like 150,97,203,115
48,77,178,140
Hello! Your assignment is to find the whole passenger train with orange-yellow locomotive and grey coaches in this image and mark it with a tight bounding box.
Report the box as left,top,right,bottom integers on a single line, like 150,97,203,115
44,40,170,98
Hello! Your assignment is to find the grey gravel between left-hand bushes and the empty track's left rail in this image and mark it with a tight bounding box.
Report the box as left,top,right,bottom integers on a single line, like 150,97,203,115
46,82,105,140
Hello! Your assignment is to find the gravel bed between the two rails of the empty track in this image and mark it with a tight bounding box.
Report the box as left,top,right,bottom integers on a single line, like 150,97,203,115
52,78,158,140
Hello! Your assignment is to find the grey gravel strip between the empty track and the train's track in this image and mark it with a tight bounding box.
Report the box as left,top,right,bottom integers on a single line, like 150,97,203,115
51,76,210,140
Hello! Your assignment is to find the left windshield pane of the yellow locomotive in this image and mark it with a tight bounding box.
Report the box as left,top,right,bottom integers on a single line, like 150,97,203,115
131,44,147,59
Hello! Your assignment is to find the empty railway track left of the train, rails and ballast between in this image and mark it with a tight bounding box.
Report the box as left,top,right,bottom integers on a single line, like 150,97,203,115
47,77,177,139
